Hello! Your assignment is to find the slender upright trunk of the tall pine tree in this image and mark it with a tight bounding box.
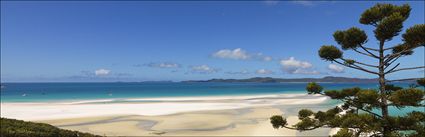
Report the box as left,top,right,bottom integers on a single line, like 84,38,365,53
379,41,390,136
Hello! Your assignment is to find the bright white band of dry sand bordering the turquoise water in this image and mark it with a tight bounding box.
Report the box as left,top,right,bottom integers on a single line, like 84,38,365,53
1,94,328,120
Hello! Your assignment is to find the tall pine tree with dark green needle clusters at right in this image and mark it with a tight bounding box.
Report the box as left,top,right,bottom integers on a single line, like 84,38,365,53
270,4,425,137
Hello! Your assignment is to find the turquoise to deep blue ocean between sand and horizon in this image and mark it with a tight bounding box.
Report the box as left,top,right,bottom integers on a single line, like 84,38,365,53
0,82,424,115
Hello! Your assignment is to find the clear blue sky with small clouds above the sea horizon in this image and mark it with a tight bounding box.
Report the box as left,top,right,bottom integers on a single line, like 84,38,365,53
1,1,425,82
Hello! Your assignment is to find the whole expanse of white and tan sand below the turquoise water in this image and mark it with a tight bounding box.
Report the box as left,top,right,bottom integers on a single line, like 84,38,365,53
1,94,330,136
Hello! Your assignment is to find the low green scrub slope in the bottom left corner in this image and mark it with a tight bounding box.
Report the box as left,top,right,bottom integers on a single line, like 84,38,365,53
0,118,100,137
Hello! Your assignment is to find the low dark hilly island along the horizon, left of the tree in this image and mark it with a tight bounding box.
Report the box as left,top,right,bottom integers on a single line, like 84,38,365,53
182,76,378,83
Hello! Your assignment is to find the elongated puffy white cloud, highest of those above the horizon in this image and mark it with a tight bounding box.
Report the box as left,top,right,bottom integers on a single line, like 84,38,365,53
212,48,272,61
